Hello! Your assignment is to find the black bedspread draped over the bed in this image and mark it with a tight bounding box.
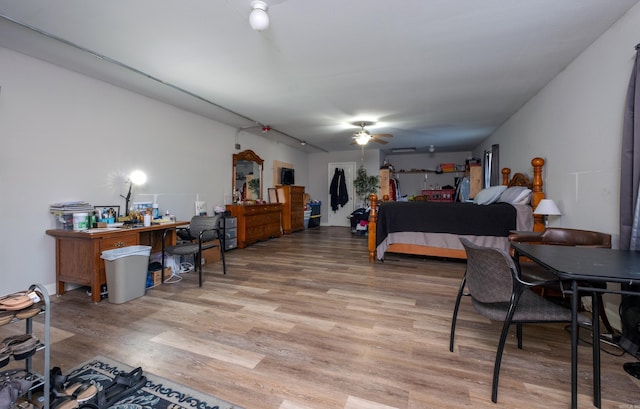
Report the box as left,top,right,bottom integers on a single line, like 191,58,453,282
376,201,517,246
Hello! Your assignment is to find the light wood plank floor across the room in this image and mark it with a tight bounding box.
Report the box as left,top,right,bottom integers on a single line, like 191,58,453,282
25,227,640,409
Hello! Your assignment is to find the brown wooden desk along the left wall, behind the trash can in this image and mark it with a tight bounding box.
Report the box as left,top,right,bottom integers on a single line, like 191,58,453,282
46,222,189,303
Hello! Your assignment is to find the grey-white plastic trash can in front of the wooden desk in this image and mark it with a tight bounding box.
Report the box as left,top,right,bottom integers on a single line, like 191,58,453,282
100,246,151,304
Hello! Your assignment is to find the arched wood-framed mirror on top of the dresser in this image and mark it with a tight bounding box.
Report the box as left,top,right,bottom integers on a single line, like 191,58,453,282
233,150,264,203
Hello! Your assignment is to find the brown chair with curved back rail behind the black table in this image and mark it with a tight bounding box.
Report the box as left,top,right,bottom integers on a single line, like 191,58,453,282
509,227,615,335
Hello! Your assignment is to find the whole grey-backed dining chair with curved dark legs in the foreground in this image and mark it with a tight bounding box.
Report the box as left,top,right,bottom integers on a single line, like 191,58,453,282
449,238,589,403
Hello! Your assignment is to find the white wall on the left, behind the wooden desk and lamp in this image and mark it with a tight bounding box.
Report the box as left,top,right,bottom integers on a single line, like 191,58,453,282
0,48,308,294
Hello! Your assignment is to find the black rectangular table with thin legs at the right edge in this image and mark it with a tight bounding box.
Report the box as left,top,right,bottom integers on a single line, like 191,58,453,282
511,243,640,409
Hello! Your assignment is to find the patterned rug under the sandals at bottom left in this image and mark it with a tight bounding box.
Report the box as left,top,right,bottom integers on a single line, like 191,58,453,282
67,355,242,409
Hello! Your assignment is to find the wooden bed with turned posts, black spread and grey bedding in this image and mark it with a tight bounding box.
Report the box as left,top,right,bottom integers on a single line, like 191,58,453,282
368,158,544,261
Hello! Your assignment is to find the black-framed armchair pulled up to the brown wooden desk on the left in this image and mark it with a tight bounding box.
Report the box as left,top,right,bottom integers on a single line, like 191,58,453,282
162,214,227,287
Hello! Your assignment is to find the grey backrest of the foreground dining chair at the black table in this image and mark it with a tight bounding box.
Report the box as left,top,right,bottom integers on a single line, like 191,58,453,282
460,238,516,303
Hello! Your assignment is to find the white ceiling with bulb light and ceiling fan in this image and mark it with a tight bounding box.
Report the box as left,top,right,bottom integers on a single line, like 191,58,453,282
0,0,639,152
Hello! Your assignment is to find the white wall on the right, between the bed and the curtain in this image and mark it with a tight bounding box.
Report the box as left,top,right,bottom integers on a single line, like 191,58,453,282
474,4,640,245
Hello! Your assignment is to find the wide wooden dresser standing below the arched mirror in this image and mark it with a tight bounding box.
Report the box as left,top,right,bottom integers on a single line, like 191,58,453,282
227,203,282,249
